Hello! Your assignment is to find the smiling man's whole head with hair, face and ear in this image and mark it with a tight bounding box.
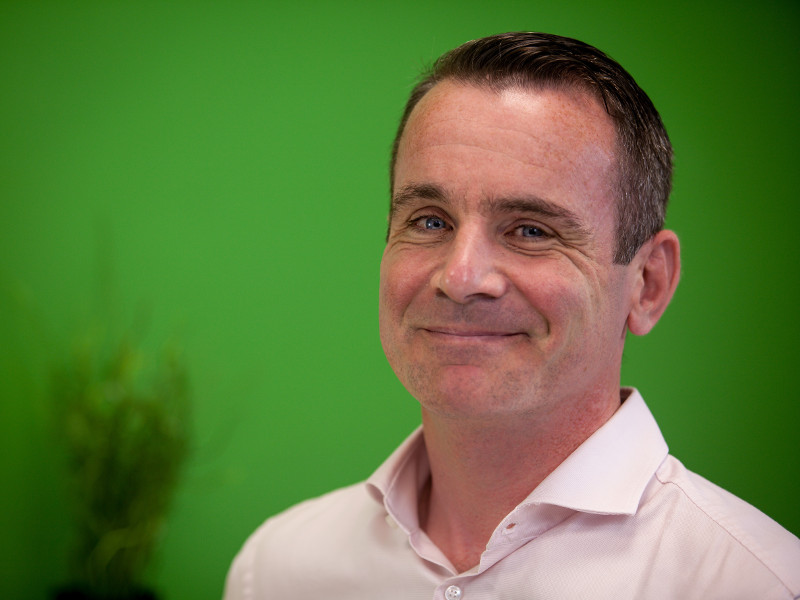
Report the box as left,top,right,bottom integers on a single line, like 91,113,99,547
379,34,679,429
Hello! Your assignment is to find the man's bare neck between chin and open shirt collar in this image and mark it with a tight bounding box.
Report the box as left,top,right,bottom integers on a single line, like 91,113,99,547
419,394,620,572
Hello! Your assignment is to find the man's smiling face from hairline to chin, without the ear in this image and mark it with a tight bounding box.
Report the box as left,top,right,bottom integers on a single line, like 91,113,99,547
380,81,634,419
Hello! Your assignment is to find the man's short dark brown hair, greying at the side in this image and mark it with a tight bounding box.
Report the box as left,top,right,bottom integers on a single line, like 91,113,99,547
390,32,672,264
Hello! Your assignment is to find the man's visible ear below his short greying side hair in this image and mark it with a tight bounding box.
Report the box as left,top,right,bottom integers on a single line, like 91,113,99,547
628,230,681,335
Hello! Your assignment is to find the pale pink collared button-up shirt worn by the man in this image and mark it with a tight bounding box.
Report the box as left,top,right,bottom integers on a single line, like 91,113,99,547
225,389,800,600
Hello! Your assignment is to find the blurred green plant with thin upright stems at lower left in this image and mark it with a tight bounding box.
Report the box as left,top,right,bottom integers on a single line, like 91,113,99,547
52,332,190,599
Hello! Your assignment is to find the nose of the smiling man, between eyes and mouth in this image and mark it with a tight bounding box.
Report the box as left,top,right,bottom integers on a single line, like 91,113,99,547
431,227,508,304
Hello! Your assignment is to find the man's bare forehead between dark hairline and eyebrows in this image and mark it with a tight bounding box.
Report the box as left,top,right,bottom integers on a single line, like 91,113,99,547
393,81,616,225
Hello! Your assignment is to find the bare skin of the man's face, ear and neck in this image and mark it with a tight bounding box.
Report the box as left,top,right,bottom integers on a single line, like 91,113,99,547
379,81,679,571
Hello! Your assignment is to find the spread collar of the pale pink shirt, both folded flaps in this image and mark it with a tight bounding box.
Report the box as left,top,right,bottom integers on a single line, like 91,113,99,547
367,388,668,533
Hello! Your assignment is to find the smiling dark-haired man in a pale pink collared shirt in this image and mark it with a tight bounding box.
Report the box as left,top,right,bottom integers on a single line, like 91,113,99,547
226,33,800,600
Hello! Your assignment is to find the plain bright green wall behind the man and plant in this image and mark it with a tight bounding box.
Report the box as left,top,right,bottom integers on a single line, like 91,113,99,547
0,0,800,599
